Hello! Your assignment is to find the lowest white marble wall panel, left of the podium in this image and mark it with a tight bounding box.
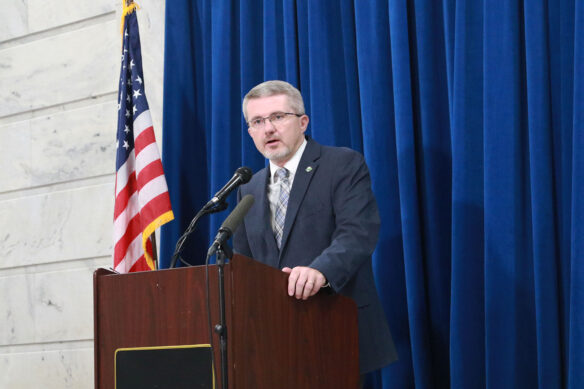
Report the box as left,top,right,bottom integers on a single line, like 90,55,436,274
0,345,93,389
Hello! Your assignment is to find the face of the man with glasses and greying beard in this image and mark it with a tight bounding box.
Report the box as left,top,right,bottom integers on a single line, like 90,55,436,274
247,95,309,167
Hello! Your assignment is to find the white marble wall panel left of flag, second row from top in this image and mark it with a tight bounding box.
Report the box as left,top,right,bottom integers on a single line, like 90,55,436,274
0,21,121,117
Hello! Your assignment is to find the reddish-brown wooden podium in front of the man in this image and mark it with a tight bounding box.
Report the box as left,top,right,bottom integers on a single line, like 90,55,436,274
93,255,359,389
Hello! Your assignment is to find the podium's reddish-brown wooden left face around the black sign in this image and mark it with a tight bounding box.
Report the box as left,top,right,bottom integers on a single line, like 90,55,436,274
94,266,231,389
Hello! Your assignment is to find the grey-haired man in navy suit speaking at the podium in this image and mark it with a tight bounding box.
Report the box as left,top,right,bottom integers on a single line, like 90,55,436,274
234,81,397,375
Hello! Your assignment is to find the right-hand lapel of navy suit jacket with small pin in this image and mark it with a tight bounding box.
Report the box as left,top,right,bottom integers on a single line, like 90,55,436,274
278,138,320,258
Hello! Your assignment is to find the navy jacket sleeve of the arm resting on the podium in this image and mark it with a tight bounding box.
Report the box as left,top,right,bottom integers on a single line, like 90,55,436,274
310,153,380,292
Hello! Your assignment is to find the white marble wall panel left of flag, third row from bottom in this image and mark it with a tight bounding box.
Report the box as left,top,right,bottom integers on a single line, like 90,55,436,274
0,183,114,269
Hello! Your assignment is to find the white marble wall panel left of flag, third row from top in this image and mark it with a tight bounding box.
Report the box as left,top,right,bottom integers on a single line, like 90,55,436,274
0,100,117,192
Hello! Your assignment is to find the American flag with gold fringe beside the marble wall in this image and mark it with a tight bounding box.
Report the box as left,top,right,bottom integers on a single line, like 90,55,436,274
114,7,174,273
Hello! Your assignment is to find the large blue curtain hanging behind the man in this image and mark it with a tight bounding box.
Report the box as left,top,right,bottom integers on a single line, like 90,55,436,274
161,0,584,389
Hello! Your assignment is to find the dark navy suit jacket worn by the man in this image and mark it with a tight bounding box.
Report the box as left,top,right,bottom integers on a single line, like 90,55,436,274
233,138,397,374
